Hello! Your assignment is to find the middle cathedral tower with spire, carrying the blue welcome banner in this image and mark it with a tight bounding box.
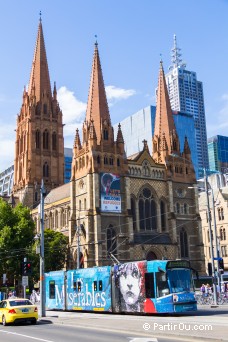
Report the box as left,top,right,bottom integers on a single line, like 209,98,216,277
71,42,127,267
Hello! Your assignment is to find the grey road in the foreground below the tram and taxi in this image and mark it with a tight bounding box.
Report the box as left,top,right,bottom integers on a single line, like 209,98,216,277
0,307,228,342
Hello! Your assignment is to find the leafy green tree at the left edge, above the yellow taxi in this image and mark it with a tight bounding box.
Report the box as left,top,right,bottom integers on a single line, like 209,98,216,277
0,198,35,282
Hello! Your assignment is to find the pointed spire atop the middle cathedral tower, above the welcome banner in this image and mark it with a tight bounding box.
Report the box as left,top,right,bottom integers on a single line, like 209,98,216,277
86,42,111,144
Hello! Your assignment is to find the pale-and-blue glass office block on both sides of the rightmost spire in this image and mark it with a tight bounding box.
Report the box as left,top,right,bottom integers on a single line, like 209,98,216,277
114,106,198,177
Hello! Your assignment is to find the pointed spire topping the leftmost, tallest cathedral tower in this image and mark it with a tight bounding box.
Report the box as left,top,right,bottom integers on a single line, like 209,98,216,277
28,17,52,102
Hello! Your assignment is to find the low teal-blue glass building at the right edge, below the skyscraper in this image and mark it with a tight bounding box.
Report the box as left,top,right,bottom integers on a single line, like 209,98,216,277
207,135,228,173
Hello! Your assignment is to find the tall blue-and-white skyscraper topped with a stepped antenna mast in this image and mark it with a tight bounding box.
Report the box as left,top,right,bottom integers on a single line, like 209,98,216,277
166,35,209,176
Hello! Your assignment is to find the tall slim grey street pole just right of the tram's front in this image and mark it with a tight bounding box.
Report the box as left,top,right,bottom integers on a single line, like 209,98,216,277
204,169,217,305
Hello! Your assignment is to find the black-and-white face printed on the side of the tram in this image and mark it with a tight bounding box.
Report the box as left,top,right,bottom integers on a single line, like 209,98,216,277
119,263,141,310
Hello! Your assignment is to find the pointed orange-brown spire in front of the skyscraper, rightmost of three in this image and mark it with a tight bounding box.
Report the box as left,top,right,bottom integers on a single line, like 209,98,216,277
154,61,176,153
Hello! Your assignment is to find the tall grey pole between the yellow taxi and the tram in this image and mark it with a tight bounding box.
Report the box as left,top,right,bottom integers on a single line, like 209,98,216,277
40,179,46,317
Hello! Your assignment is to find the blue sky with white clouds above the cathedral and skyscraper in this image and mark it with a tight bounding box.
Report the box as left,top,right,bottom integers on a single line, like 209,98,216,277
0,0,228,171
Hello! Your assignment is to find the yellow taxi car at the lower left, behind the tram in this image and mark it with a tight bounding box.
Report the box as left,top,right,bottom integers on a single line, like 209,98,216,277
0,298,38,326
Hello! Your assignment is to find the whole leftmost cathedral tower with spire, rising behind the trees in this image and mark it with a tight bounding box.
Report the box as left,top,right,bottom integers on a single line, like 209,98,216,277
13,19,64,207
